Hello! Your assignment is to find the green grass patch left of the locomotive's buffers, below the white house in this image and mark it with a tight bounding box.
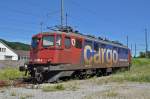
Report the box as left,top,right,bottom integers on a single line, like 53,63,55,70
0,67,24,80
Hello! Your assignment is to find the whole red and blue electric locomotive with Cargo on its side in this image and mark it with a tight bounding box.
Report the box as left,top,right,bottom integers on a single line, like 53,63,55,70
20,27,131,83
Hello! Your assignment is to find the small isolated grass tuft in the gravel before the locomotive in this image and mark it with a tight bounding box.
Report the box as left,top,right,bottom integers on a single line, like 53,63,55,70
42,84,65,92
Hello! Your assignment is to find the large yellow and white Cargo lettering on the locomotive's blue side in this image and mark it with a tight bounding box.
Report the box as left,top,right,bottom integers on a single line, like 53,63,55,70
84,45,118,66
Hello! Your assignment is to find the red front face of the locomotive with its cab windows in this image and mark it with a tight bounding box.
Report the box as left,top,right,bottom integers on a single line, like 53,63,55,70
30,33,62,65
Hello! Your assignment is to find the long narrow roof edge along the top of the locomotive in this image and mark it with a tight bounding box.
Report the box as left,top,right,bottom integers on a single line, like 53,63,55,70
35,31,128,49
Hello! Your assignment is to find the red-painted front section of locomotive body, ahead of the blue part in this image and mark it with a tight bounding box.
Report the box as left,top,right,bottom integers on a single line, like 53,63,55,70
30,32,83,66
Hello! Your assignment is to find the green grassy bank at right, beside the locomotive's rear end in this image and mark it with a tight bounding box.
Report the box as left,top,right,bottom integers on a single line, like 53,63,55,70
107,58,150,82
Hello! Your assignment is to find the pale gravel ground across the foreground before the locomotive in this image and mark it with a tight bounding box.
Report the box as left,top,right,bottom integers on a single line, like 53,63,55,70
0,80,150,99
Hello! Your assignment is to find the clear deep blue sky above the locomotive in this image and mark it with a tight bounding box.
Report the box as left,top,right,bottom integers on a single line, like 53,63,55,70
0,0,150,55
